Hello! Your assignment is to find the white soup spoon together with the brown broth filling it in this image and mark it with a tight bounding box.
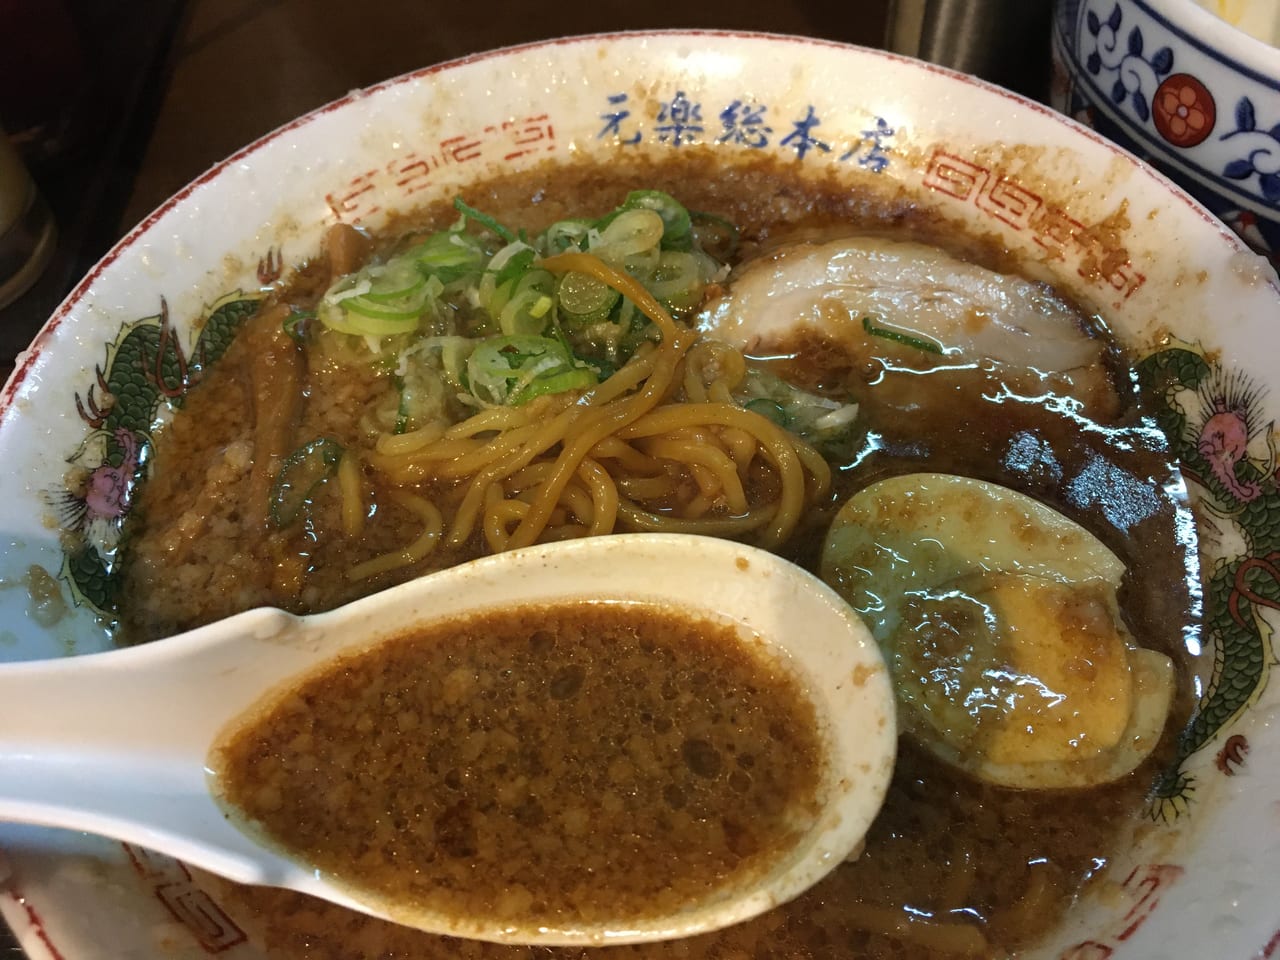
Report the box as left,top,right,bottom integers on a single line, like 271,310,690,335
0,534,896,945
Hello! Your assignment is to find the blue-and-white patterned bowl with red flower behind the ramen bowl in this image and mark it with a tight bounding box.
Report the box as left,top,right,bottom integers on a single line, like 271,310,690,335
1051,0,1280,262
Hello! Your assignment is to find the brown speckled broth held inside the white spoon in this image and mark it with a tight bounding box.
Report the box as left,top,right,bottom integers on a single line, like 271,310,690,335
212,603,823,928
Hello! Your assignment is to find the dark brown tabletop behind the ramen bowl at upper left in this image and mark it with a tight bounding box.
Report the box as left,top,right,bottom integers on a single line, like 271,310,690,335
0,0,888,957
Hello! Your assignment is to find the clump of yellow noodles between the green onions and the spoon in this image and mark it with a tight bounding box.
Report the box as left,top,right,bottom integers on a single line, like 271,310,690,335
360,252,829,549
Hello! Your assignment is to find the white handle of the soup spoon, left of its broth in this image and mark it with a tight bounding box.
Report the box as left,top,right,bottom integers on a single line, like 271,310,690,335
0,609,311,883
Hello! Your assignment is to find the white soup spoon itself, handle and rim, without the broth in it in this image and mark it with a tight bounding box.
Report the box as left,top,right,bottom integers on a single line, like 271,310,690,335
0,534,896,945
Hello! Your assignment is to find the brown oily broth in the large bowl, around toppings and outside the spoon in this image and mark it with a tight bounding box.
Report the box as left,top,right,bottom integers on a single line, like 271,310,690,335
122,156,1192,960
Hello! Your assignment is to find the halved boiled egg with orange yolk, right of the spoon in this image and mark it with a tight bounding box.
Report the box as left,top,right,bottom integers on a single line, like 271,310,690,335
820,474,1174,788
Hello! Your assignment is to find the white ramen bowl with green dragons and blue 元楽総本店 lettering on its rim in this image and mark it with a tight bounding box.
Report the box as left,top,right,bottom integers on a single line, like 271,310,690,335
0,32,1280,960
